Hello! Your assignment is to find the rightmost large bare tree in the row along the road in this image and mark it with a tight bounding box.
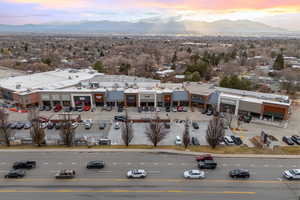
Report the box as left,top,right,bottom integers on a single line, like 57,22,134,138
206,116,225,148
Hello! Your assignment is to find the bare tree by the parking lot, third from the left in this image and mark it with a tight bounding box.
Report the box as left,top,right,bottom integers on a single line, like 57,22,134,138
60,114,76,147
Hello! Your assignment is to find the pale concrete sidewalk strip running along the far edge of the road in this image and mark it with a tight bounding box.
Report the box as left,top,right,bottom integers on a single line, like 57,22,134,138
0,149,300,159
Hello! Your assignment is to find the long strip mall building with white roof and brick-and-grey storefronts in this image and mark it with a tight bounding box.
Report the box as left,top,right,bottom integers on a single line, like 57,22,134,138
0,69,291,120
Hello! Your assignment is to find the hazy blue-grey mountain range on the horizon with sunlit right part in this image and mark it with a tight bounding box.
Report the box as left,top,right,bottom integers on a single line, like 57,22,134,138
0,20,287,35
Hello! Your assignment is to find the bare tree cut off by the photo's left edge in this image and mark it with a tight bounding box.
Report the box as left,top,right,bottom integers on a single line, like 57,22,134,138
0,108,14,146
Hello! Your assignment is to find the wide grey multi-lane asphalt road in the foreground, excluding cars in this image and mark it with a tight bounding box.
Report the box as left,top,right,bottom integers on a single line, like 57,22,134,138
0,152,300,200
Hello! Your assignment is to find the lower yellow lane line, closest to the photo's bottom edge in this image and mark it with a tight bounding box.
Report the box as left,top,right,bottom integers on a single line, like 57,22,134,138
0,189,256,195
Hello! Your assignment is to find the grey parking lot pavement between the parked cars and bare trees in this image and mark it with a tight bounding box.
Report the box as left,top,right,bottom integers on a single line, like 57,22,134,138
4,104,300,147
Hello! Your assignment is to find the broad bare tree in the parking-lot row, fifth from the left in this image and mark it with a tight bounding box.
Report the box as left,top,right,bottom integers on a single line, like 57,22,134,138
145,115,169,147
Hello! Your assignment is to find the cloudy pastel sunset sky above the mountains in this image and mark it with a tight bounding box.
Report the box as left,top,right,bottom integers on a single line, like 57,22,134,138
0,0,300,30
